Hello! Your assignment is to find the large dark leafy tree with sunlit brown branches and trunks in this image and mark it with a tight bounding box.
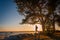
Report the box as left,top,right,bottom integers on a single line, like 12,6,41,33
15,0,60,31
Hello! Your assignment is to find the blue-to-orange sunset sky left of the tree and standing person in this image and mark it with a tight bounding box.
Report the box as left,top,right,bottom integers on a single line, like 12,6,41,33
0,0,60,31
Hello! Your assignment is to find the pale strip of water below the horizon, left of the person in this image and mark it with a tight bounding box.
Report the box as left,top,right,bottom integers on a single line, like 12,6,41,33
0,31,34,39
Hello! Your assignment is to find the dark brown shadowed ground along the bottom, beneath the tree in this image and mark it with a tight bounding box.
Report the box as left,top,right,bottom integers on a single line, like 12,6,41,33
0,32,60,40
